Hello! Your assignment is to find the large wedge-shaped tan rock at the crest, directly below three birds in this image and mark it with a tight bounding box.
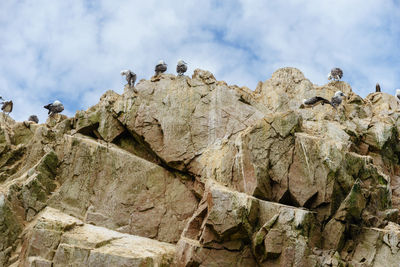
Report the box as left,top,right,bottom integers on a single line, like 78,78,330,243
113,70,263,170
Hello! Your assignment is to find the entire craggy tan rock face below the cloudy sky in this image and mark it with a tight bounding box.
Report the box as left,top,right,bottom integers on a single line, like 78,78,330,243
0,68,400,266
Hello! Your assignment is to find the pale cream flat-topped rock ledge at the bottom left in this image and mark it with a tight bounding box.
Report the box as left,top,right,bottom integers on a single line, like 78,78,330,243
20,208,175,266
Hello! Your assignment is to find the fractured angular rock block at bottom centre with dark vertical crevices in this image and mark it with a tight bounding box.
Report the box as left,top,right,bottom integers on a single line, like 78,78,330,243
177,182,315,266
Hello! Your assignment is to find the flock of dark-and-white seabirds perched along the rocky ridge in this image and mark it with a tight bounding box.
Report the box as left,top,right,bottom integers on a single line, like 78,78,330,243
0,64,400,123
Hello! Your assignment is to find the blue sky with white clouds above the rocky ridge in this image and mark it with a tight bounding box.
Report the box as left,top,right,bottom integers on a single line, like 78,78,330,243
0,0,400,122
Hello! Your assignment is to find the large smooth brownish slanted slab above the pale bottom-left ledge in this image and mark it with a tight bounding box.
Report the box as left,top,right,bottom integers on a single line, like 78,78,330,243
48,134,198,242
